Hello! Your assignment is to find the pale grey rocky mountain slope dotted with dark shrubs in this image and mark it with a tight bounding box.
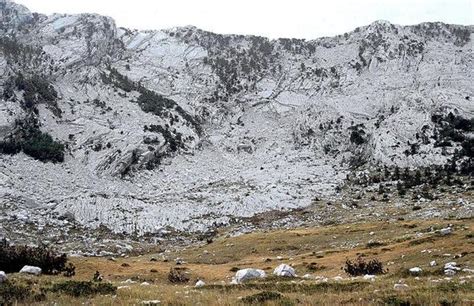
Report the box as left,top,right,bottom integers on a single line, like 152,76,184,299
0,0,474,249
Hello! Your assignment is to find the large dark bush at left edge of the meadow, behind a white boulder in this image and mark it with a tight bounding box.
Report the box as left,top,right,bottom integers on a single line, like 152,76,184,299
0,240,71,274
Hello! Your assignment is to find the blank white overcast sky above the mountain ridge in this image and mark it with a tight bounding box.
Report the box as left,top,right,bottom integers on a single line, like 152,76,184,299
15,0,474,39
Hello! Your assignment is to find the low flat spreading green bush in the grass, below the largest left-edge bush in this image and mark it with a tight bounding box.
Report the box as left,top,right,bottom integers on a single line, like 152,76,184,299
48,281,117,297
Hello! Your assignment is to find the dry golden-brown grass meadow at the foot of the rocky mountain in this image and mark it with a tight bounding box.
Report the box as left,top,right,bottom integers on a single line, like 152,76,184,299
4,219,474,305
